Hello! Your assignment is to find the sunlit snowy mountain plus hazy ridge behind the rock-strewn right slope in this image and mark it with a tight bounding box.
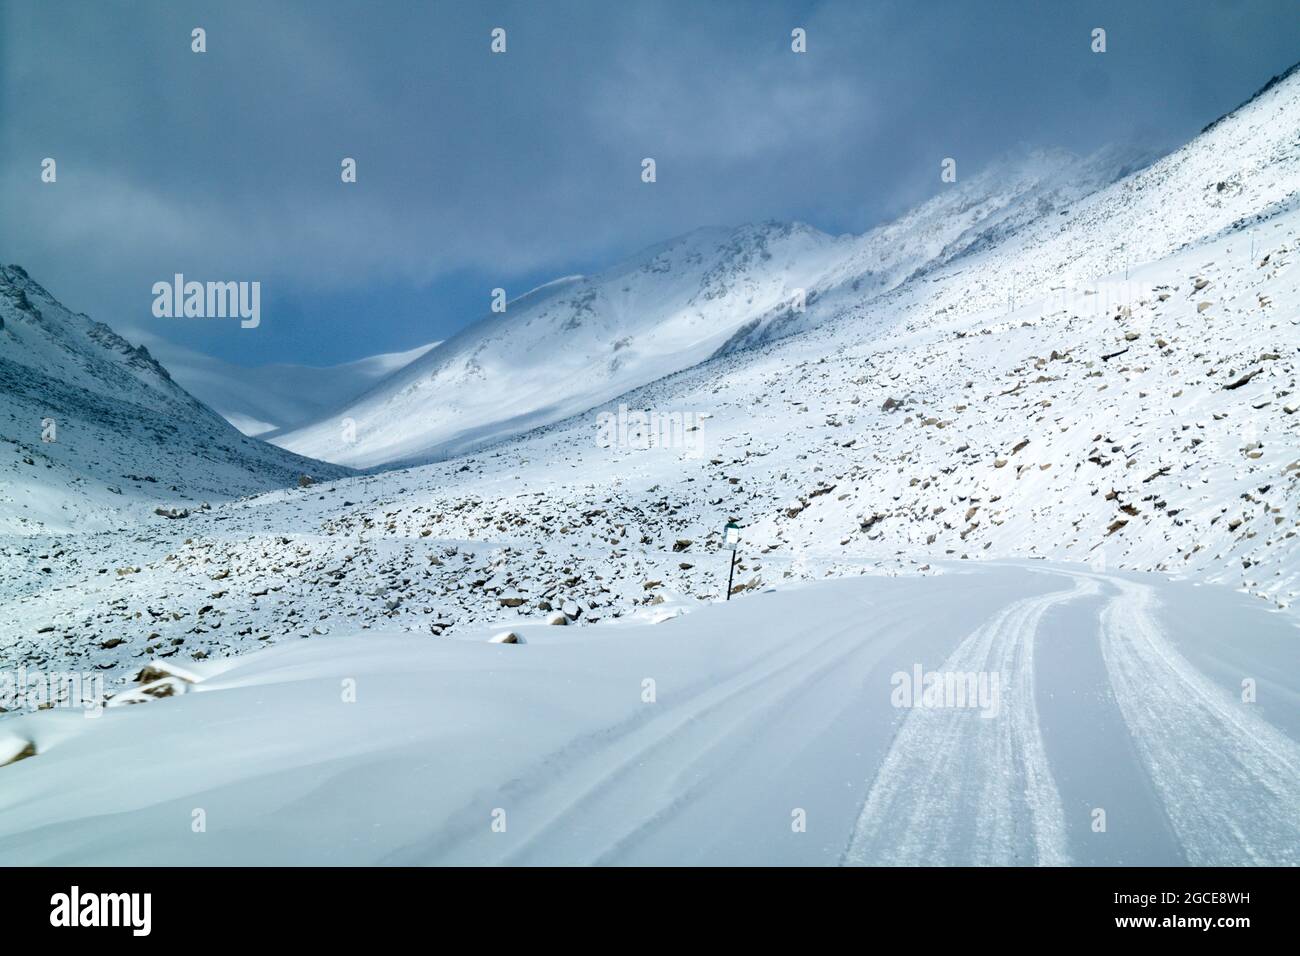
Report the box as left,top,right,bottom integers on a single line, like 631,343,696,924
270,150,1140,467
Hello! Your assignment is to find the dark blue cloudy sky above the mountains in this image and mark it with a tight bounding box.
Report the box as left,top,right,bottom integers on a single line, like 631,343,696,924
0,0,1300,364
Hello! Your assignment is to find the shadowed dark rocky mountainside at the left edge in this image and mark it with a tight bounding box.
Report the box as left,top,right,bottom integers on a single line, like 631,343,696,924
0,265,346,533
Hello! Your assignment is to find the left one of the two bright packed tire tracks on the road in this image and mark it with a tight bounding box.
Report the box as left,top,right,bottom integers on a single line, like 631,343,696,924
841,572,1100,866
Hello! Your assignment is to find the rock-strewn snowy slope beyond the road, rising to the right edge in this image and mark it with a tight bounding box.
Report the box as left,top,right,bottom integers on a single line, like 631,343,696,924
0,54,1300,681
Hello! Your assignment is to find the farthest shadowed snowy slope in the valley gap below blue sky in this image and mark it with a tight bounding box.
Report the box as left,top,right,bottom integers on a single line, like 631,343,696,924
146,337,438,438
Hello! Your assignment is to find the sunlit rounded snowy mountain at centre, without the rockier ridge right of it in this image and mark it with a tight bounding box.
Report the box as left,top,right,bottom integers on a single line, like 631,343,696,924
273,222,849,466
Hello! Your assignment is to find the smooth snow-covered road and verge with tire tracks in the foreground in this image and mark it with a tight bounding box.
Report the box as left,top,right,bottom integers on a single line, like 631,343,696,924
0,562,1300,865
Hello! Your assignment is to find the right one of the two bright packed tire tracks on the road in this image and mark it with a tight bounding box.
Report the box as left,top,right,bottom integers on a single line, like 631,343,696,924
1101,579,1300,866
